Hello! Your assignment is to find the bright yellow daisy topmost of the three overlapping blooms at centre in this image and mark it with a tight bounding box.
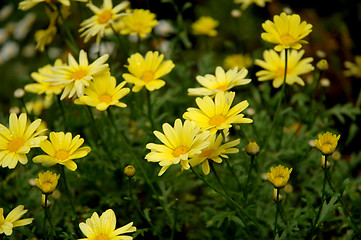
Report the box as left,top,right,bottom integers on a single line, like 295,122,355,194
183,92,253,134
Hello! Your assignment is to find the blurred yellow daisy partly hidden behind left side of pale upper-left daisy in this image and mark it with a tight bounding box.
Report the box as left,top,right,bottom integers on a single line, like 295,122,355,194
25,59,64,99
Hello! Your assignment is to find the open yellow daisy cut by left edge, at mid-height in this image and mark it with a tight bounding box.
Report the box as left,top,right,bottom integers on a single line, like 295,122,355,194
0,113,47,169
